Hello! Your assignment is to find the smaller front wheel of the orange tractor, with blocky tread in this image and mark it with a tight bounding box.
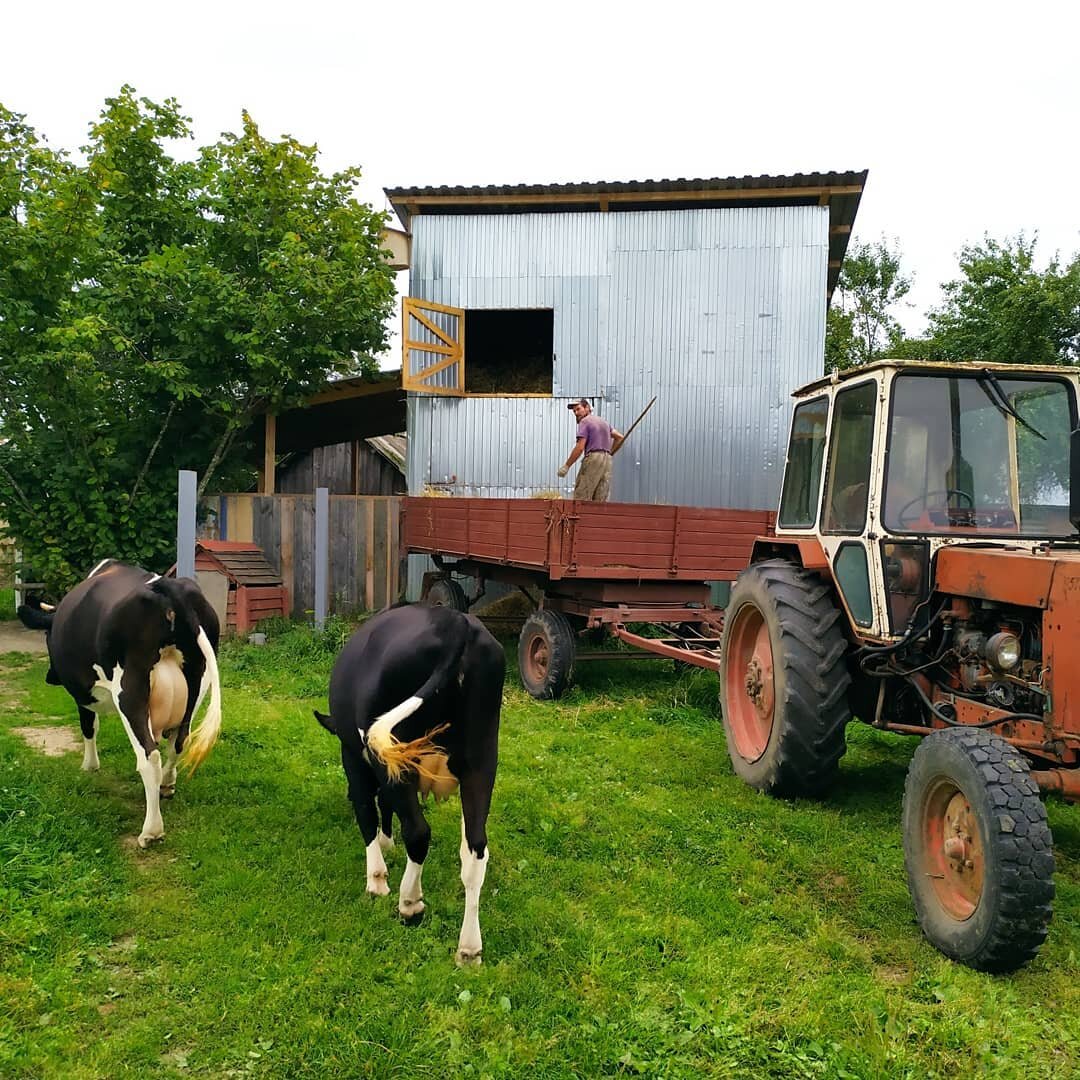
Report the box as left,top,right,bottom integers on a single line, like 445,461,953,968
904,728,1054,972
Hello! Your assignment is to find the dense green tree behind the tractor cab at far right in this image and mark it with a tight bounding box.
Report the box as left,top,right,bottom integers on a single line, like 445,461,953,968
930,235,1080,364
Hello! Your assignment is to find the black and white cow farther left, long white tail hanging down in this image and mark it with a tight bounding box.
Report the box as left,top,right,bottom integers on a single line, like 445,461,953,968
18,559,221,848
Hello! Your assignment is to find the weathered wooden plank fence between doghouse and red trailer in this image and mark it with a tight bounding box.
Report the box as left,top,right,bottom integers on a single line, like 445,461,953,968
200,494,404,619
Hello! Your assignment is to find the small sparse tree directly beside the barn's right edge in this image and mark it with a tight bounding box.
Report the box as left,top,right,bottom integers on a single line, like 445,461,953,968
825,238,912,368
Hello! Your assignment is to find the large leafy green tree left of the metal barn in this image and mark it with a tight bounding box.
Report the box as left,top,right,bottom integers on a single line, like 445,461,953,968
0,86,393,589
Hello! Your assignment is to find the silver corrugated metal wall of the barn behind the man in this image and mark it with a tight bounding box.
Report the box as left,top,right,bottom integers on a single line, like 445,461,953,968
408,206,828,518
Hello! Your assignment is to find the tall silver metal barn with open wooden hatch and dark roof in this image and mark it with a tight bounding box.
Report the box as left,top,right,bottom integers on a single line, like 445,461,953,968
387,172,866,509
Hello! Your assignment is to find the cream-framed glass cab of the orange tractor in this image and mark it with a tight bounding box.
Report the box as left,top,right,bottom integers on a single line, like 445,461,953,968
777,360,1080,640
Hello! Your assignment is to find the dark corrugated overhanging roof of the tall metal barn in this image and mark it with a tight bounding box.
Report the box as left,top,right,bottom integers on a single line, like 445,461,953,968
383,170,867,296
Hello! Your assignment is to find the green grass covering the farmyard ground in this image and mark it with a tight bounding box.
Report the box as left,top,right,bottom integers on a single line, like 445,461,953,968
0,627,1080,1078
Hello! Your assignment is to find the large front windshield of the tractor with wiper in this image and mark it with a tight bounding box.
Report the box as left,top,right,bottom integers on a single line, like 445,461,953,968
882,368,1074,538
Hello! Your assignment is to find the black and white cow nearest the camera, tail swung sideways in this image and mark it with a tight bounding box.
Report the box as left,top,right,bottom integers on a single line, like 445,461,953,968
315,605,507,963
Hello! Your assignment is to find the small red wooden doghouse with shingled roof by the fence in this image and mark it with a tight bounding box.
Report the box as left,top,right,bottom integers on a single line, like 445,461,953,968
168,540,289,634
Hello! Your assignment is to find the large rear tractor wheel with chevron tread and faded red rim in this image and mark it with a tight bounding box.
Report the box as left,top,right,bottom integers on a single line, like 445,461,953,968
720,559,851,798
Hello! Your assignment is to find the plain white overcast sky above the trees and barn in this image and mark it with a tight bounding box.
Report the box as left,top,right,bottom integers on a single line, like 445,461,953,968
0,0,1080,345
